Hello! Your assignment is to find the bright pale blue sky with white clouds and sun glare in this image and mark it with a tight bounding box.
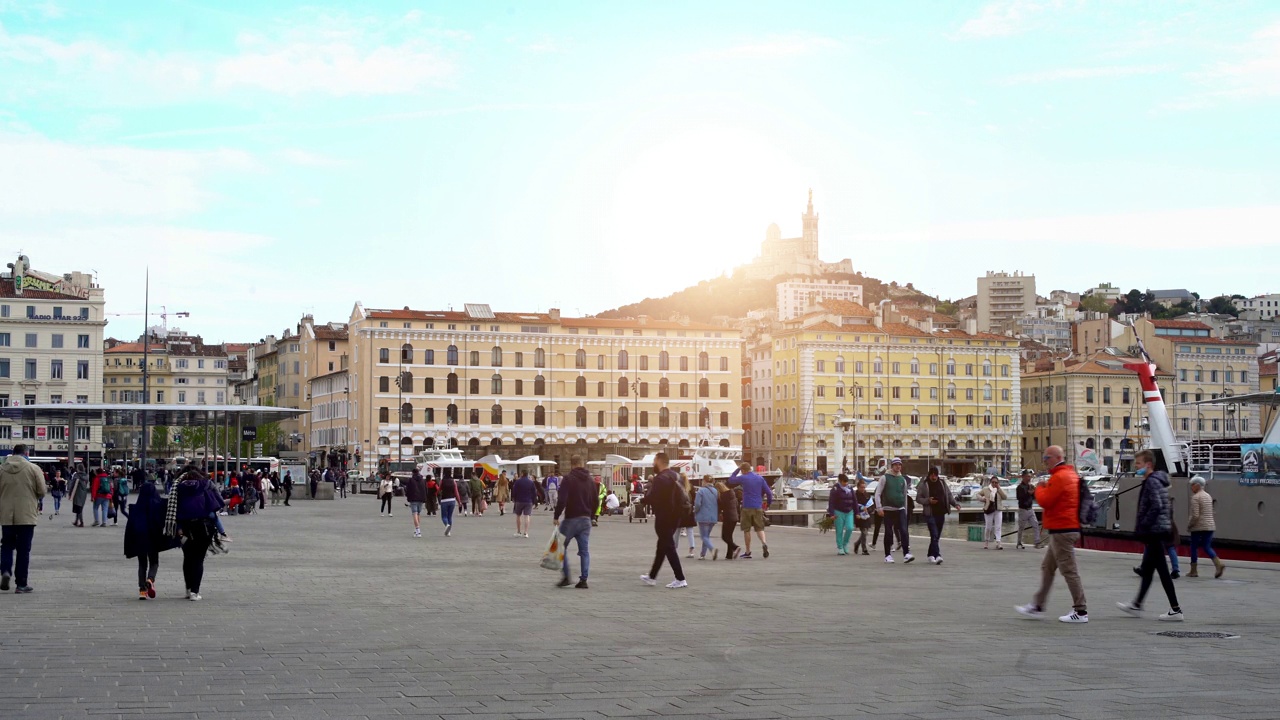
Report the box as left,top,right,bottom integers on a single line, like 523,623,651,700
0,0,1280,342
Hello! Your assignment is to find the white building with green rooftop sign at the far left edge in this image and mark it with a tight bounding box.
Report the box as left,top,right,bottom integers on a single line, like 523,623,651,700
0,255,106,462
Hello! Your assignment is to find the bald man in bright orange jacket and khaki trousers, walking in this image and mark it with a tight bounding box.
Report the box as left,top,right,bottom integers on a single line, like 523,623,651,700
1016,445,1089,623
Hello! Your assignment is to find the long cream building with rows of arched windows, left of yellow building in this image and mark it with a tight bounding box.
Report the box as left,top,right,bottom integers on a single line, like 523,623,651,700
348,304,742,471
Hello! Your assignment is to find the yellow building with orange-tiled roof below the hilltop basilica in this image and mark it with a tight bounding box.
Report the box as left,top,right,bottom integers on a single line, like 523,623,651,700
755,302,1021,474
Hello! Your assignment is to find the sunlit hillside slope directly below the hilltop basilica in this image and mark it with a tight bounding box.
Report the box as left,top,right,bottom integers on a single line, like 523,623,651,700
596,272,934,323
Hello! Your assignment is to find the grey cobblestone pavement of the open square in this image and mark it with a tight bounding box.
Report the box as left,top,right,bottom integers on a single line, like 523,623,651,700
0,496,1280,720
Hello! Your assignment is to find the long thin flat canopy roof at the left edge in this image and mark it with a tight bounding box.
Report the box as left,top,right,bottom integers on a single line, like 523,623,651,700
0,402,310,428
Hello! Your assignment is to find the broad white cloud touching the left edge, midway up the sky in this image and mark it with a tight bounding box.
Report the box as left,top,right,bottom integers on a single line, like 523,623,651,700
0,131,255,218
